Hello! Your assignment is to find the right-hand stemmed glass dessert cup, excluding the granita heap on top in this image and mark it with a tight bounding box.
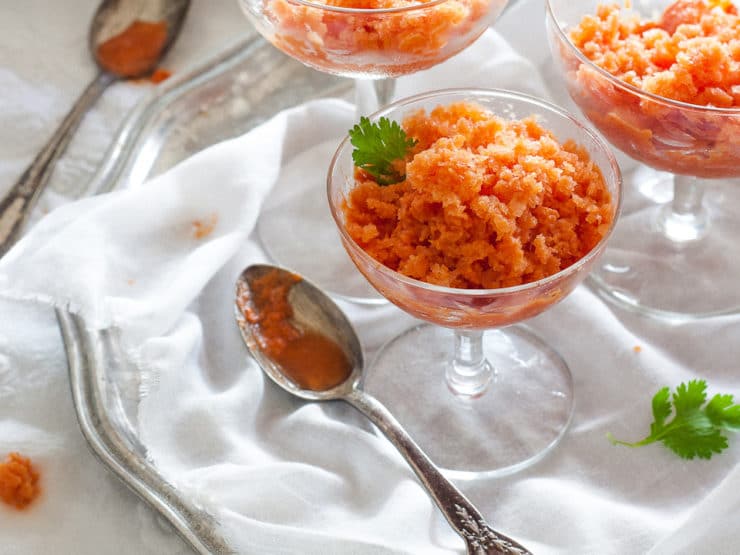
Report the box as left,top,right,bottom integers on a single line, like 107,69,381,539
547,0,740,321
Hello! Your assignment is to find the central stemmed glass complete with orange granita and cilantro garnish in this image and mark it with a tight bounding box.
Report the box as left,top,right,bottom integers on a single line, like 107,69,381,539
327,89,622,479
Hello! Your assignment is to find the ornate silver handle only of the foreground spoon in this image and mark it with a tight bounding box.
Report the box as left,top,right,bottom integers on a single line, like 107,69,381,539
342,389,532,555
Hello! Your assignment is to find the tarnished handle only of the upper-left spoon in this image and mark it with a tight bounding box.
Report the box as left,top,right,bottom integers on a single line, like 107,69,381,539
0,71,118,257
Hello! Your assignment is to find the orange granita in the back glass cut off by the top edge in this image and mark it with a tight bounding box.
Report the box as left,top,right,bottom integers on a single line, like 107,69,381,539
263,0,498,75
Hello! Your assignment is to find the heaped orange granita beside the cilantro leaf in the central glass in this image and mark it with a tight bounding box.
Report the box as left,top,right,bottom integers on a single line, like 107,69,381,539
343,102,614,289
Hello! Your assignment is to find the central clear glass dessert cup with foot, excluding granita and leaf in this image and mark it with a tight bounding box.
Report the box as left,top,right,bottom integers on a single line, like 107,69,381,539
328,90,621,479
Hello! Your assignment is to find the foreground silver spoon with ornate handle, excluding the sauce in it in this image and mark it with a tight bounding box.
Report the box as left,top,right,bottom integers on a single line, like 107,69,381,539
236,264,531,555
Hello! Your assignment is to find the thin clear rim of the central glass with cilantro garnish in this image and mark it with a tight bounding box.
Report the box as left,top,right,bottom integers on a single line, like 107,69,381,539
326,88,622,297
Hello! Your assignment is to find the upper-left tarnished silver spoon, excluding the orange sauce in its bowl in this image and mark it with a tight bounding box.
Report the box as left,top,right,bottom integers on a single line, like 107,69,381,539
0,0,190,257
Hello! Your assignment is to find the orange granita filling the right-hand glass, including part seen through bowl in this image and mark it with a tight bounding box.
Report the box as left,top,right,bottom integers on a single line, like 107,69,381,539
561,0,740,178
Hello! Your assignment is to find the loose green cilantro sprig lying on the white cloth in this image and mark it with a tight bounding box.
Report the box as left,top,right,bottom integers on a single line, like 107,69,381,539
607,380,740,459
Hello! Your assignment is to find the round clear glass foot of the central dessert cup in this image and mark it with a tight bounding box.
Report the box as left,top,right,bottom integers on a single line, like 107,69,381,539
363,324,573,479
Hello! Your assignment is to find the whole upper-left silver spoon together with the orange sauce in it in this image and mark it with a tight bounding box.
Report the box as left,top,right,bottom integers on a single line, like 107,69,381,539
0,0,190,257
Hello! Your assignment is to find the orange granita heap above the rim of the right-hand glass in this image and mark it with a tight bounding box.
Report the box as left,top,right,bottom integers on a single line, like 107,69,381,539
570,0,740,108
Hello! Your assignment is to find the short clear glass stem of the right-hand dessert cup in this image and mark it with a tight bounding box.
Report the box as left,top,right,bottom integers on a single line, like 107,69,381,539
658,175,709,243
